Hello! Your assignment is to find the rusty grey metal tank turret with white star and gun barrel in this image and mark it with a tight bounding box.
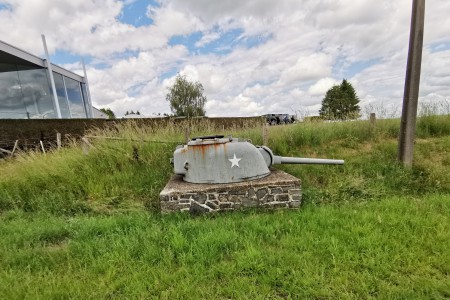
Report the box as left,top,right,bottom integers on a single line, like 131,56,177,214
173,136,344,183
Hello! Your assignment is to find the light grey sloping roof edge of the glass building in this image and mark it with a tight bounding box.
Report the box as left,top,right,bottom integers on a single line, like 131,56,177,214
0,40,85,82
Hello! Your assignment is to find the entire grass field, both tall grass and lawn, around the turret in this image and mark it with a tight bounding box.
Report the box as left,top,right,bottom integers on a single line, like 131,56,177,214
0,116,450,299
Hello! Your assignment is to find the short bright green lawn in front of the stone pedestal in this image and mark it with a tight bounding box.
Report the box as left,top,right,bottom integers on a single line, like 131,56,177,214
0,195,450,299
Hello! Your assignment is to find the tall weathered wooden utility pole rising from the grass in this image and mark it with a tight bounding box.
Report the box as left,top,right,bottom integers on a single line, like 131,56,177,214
398,0,425,167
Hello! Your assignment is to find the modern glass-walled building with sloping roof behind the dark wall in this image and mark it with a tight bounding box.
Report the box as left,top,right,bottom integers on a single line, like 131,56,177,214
0,41,93,119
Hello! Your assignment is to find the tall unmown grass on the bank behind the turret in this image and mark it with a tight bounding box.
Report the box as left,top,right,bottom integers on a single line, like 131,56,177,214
0,115,450,215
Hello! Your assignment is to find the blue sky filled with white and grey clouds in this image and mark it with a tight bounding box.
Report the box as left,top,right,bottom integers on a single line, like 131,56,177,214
0,0,450,116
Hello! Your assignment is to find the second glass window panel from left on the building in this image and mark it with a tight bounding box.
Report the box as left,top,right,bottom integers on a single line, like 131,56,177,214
18,66,56,119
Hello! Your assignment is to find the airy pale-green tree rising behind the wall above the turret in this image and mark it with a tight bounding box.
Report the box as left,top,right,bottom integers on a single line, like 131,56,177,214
166,74,207,117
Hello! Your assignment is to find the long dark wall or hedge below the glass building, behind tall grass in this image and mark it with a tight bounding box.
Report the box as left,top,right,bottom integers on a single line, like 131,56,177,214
0,117,265,149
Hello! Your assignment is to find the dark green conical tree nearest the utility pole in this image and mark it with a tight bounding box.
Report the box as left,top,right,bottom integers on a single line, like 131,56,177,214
319,79,360,120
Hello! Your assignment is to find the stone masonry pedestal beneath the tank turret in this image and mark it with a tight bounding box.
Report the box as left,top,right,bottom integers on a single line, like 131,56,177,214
159,169,301,214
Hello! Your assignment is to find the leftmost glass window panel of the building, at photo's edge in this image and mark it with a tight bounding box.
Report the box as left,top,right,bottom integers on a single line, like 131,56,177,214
0,63,28,119
